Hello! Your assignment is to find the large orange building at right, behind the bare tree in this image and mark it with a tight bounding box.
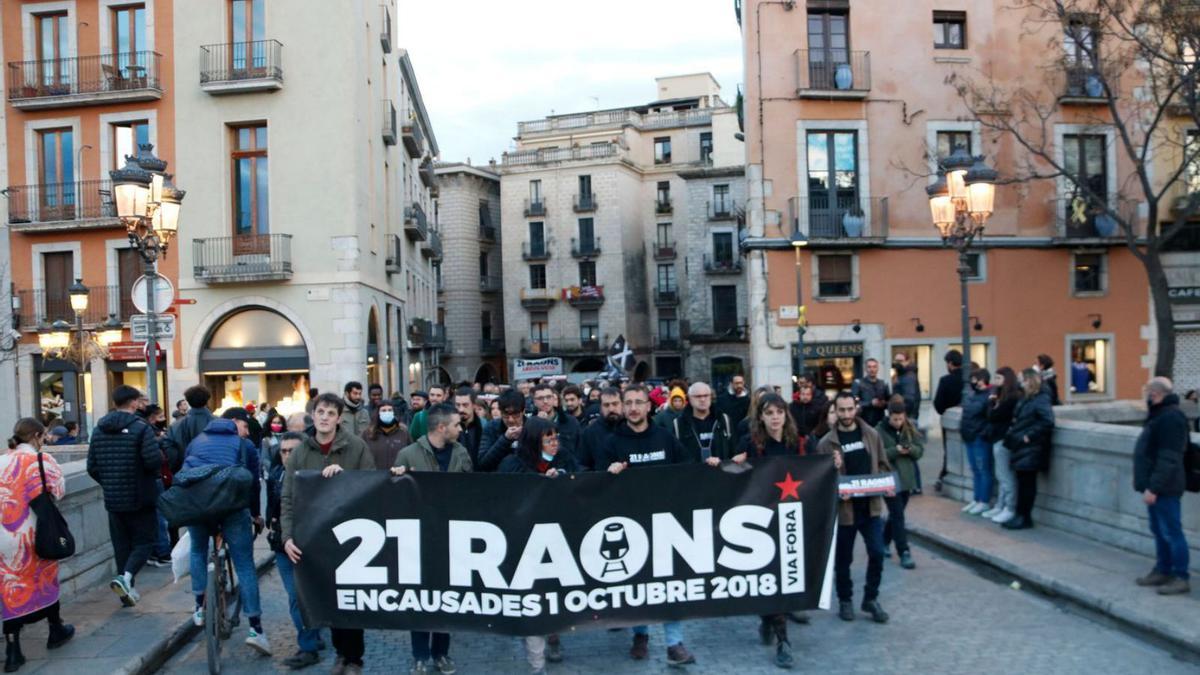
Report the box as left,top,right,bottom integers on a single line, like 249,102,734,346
738,0,1153,402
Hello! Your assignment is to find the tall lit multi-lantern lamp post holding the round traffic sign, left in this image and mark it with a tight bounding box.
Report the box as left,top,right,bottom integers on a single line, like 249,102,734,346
108,143,185,402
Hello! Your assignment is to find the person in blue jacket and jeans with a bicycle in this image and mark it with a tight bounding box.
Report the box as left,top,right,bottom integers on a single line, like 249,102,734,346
184,406,271,656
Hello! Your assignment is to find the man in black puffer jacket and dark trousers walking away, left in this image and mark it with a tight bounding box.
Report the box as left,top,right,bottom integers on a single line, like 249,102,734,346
88,384,162,607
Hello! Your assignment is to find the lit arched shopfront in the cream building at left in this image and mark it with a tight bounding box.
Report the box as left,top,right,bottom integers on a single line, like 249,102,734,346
199,306,308,414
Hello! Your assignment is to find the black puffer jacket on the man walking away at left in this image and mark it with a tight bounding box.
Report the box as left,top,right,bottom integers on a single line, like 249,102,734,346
88,411,162,513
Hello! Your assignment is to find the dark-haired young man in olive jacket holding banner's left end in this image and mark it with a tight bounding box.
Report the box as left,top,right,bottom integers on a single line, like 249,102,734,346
280,393,374,675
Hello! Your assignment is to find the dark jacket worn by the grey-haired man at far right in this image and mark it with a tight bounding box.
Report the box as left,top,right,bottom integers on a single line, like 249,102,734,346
1133,394,1188,497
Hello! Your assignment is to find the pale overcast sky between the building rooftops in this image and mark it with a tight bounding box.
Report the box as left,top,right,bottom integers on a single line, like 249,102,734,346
396,0,742,165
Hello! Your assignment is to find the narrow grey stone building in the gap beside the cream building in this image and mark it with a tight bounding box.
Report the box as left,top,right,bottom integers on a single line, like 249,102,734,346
437,163,508,383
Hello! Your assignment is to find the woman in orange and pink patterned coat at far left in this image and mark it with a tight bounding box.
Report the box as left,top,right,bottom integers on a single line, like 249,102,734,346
0,417,74,673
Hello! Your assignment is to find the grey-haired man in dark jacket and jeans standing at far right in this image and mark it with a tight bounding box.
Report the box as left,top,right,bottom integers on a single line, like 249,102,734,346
1133,377,1192,596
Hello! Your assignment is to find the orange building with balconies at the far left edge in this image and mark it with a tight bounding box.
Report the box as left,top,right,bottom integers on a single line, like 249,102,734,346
0,0,178,430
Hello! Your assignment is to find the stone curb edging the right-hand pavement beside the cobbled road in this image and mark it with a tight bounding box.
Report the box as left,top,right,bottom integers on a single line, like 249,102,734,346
907,522,1200,656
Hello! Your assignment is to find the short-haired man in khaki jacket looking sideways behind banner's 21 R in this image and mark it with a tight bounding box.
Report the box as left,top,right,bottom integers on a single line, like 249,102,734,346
391,404,472,675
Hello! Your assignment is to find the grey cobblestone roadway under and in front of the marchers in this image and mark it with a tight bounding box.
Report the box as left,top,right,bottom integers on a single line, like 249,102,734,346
163,530,1196,675
